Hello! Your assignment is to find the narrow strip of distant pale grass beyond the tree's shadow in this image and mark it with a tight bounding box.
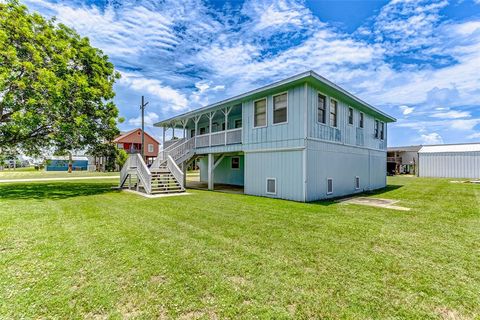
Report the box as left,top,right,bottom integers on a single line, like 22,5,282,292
0,168,119,180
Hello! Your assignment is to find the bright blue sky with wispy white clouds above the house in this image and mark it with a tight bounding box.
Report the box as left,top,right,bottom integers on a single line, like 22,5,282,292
23,0,480,146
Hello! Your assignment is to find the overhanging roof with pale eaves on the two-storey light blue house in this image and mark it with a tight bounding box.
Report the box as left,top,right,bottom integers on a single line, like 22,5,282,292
155,70,396,127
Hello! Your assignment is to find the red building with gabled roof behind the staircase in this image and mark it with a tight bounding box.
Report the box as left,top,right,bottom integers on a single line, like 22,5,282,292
113,128,160,163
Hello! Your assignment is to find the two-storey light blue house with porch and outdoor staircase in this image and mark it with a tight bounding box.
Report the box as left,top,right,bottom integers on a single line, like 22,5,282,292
121,71,395,202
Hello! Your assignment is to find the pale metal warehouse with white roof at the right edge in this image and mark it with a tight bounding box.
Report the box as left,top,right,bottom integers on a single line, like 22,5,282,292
418,143,480,178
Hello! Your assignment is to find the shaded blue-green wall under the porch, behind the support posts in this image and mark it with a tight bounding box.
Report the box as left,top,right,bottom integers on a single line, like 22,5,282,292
198,156,245,186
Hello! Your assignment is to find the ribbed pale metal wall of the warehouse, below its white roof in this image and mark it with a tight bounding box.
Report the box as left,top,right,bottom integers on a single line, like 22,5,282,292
418,152,480,179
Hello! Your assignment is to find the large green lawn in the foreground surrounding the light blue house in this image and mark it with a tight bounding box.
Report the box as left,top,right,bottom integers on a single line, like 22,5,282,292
0,177,480,319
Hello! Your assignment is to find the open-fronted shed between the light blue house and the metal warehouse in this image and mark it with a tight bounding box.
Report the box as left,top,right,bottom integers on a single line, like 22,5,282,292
387,146,422,174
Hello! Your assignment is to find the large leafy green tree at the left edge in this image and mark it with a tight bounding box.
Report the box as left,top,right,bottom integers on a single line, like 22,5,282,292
0,0,119,171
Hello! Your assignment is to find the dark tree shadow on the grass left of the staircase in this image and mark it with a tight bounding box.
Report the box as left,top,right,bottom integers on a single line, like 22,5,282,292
0,182,118,200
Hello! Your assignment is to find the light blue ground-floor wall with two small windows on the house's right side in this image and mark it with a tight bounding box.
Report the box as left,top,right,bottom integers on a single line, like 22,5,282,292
307,141,386,201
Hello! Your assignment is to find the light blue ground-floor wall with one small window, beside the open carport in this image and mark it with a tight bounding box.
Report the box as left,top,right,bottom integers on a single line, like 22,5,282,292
245,150,304,201
